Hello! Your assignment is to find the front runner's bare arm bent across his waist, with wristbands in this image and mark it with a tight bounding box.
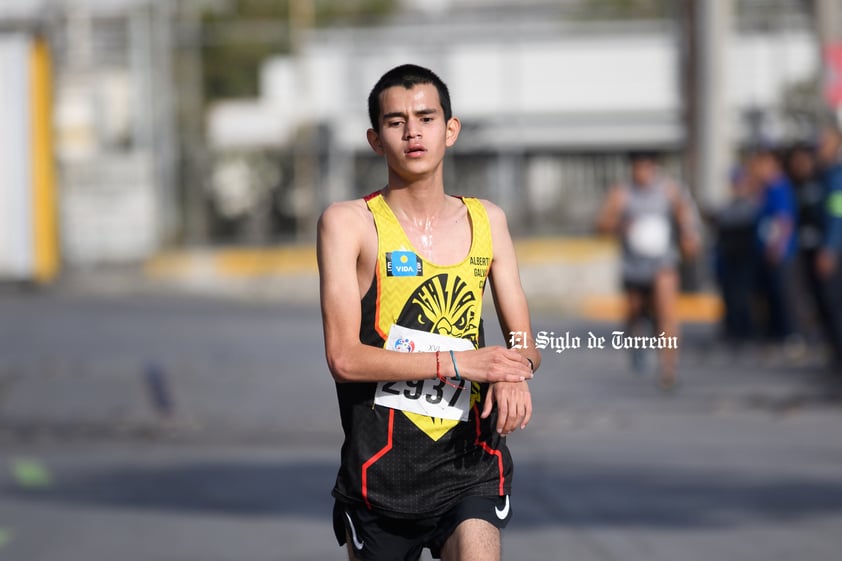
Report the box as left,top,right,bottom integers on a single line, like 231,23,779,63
316,202,532,382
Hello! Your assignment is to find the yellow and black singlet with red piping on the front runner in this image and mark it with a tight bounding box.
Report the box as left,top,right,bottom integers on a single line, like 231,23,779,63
333,191,512,518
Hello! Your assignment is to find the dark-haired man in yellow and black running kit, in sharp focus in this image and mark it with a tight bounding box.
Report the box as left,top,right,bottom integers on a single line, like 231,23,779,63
317,65,540,561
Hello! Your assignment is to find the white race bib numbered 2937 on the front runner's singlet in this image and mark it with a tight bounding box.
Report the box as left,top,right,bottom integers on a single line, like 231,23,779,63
374,325,474,421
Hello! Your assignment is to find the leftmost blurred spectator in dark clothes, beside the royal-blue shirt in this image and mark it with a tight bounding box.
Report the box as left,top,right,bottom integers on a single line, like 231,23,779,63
714,167,759,346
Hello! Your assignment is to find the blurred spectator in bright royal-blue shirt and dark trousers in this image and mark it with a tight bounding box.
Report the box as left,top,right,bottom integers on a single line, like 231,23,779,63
748,148,797,350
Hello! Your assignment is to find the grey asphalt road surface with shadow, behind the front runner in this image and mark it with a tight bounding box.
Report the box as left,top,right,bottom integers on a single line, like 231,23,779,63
0,289,842,561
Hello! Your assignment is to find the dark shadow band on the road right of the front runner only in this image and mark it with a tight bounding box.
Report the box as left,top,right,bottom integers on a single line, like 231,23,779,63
513,464,842,528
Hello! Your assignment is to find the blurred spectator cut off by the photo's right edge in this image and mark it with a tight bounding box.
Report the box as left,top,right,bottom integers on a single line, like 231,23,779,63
814,127,842,373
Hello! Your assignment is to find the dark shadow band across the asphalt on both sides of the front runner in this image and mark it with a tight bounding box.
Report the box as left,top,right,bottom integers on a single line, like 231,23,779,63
6,461,842,529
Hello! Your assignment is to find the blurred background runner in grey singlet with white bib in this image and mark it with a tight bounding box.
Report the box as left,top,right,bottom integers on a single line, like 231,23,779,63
597,152,699,389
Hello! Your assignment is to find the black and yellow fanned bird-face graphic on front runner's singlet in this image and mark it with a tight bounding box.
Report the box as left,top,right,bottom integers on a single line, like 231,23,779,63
396,273,480,440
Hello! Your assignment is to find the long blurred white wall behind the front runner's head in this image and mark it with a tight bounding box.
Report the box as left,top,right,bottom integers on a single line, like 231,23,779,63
208,22,819,149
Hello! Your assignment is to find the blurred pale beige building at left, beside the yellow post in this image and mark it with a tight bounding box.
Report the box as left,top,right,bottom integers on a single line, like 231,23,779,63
0,0,218,267
